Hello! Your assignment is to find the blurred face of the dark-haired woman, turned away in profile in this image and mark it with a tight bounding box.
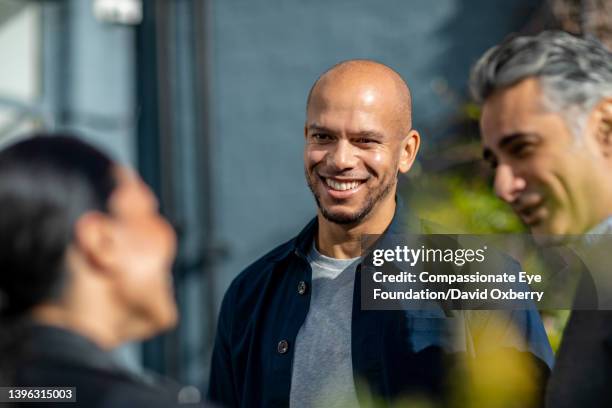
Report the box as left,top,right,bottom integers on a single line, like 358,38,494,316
109,169,177,335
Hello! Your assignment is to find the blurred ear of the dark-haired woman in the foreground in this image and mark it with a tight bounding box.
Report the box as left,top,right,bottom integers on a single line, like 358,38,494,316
74,211,117,271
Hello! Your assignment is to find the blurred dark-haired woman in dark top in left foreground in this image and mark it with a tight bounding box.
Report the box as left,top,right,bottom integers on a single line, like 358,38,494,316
0,135,202,407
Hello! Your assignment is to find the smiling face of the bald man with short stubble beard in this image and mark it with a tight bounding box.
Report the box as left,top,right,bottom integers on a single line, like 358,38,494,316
304,83,412,224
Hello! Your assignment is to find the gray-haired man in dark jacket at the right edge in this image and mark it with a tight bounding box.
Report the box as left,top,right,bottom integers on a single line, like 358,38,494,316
471,31,612,408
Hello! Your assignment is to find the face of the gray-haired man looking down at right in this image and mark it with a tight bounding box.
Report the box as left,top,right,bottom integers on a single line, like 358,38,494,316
481,78,605,235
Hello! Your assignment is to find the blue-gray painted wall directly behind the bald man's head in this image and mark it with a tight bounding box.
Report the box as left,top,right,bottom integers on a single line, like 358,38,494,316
212,0,539,306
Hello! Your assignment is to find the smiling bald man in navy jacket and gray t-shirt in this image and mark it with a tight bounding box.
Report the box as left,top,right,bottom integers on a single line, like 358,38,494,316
209,60,548,407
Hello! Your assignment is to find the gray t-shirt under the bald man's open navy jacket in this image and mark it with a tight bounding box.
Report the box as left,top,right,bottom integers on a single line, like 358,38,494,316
290,244,360,408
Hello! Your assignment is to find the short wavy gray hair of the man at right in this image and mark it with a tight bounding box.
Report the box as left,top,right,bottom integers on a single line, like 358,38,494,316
470,31,612,135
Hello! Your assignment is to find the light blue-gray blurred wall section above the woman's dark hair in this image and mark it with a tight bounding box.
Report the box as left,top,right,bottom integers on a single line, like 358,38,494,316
48,0,136,165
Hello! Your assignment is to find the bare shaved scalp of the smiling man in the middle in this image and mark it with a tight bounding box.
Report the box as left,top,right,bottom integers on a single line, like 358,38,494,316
306,59,412,135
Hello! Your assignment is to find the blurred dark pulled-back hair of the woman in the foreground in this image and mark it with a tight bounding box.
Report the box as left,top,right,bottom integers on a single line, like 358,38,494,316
0,134,116,318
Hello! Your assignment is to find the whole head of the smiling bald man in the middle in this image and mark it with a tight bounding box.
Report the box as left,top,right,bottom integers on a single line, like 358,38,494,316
304,60,420,226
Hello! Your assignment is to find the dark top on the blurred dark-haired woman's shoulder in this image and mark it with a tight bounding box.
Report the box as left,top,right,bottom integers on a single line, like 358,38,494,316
0,323,206,408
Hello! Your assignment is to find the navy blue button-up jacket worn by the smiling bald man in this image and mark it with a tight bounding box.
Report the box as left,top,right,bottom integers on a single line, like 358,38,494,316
208,207,552,407
